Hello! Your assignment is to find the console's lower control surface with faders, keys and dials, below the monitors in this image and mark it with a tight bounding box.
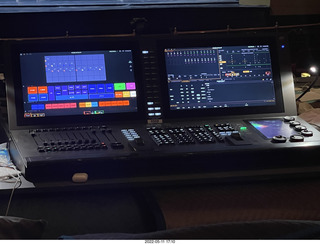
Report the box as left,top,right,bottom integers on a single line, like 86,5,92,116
8,117,320,182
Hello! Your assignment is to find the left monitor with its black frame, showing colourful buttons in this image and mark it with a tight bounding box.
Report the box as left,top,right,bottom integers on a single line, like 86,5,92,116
4,38,141,125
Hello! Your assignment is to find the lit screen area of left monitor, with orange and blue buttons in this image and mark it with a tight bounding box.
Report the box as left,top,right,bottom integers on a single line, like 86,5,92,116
20,50,137,118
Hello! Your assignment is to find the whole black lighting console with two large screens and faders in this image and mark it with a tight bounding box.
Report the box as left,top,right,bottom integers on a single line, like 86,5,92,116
7,34,320,184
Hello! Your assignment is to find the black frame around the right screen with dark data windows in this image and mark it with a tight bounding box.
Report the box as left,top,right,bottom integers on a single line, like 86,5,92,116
157,34,285,119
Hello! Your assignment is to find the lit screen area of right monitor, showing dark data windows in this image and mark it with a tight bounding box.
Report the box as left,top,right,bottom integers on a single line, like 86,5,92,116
164,45,276,111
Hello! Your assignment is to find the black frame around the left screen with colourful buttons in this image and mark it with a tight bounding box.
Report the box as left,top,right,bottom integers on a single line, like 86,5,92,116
9,38,145,127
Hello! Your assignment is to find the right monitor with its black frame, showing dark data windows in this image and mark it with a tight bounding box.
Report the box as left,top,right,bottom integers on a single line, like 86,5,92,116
161,35,292,118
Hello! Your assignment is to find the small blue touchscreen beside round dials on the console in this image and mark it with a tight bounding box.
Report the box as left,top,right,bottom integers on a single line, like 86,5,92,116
248,119,296,139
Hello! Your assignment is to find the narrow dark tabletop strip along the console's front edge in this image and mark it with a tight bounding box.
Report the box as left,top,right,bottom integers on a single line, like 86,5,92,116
0,162,320,193
